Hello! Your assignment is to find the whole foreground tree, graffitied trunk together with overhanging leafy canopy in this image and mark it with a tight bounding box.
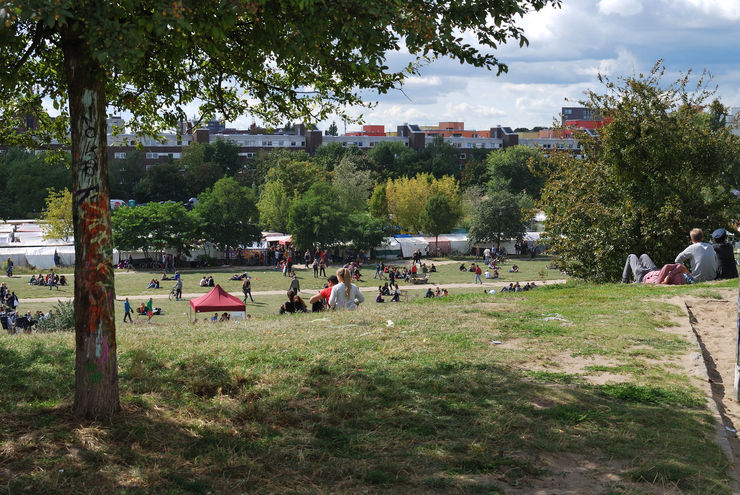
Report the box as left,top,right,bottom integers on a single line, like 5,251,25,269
0,0,559,417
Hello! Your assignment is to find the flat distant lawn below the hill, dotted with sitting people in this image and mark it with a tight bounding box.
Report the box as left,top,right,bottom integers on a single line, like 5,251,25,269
5,258,567,302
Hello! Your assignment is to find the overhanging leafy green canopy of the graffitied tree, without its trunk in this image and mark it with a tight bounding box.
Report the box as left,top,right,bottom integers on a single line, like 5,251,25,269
0,0,560,138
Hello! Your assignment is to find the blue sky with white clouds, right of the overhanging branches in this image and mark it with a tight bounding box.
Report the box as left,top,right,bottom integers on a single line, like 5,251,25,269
270,0,740,134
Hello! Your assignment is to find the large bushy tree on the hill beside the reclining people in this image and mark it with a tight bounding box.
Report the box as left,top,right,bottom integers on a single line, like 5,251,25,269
541,64,740,281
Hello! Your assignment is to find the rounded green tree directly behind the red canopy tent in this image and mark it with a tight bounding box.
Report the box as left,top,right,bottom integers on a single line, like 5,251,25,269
191,177,260,251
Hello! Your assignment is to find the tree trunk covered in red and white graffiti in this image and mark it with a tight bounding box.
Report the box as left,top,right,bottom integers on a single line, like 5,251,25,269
62,26,120,418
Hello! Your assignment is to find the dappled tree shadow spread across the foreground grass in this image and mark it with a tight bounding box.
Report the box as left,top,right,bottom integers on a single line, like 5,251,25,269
0,349,729,493
